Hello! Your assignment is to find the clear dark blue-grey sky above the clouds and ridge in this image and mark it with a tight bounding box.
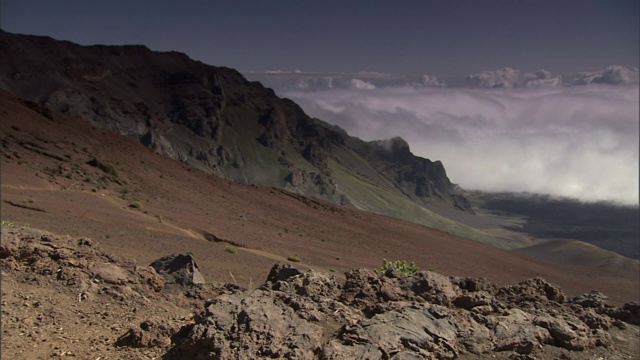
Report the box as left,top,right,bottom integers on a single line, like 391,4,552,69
0,0,640,76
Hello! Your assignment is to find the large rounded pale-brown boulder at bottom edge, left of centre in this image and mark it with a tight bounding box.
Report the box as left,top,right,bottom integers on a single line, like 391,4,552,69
179,289,322,359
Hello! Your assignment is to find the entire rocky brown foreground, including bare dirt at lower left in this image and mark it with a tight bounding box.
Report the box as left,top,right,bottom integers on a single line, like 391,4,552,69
0,223,640,359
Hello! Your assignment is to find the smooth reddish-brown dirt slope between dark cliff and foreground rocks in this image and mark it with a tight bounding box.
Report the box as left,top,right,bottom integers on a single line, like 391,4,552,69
0,93,640,305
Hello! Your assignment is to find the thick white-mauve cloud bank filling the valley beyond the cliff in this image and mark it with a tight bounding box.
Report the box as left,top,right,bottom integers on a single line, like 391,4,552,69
282,82,639,205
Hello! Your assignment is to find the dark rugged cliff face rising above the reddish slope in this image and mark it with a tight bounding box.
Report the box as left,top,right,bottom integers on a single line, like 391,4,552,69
0,32,472,217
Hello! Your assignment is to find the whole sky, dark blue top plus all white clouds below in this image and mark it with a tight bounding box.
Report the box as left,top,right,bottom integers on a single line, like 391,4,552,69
0,0,640,205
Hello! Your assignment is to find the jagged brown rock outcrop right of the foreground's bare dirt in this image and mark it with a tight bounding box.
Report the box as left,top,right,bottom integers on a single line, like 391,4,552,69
166,265,640,359
